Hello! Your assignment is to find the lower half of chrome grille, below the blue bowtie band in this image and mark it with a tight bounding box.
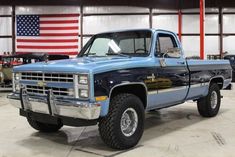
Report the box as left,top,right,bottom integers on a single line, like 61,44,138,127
26,85,74,96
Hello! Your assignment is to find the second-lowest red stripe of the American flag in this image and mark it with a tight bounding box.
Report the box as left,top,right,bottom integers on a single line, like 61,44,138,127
17,45,78,49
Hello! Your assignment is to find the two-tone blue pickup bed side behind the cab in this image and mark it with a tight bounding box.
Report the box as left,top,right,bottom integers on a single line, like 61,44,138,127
186,60,231,100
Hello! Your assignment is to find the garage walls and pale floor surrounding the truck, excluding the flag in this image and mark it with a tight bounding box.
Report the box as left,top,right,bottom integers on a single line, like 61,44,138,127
0,0,235,157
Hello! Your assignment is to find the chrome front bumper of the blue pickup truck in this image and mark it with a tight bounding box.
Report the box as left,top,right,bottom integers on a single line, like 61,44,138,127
7,93,101,120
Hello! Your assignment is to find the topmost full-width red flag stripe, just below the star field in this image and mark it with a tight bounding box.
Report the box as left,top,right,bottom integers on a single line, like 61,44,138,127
16,39,78,43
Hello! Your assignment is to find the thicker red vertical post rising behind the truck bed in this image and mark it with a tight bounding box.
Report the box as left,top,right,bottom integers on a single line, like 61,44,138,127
200,0,205,59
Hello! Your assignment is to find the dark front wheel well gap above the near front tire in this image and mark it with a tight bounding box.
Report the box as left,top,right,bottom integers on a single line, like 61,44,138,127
111,84,147,108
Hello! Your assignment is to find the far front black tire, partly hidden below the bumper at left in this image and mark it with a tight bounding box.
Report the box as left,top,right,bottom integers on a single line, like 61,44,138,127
27,117,63,133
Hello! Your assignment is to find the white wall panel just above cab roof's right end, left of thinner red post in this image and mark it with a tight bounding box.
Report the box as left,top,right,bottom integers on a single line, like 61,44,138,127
153,15,178,33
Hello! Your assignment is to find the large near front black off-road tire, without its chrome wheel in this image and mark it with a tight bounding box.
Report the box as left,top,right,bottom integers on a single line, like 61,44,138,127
99,93,145,149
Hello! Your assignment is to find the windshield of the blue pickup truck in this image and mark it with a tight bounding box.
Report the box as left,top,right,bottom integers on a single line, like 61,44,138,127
79,30,152,57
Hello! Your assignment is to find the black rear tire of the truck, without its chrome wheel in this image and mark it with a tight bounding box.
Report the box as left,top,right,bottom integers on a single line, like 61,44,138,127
197,83,221,117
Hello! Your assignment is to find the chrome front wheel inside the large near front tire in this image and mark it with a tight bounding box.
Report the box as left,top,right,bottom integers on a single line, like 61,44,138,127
120,108,138,137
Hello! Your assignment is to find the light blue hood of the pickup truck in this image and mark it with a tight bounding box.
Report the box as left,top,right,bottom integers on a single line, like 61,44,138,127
13,56,155,73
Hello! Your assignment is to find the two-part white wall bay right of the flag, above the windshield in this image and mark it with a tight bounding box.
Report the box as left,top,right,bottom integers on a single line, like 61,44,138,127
83,7,149,34
